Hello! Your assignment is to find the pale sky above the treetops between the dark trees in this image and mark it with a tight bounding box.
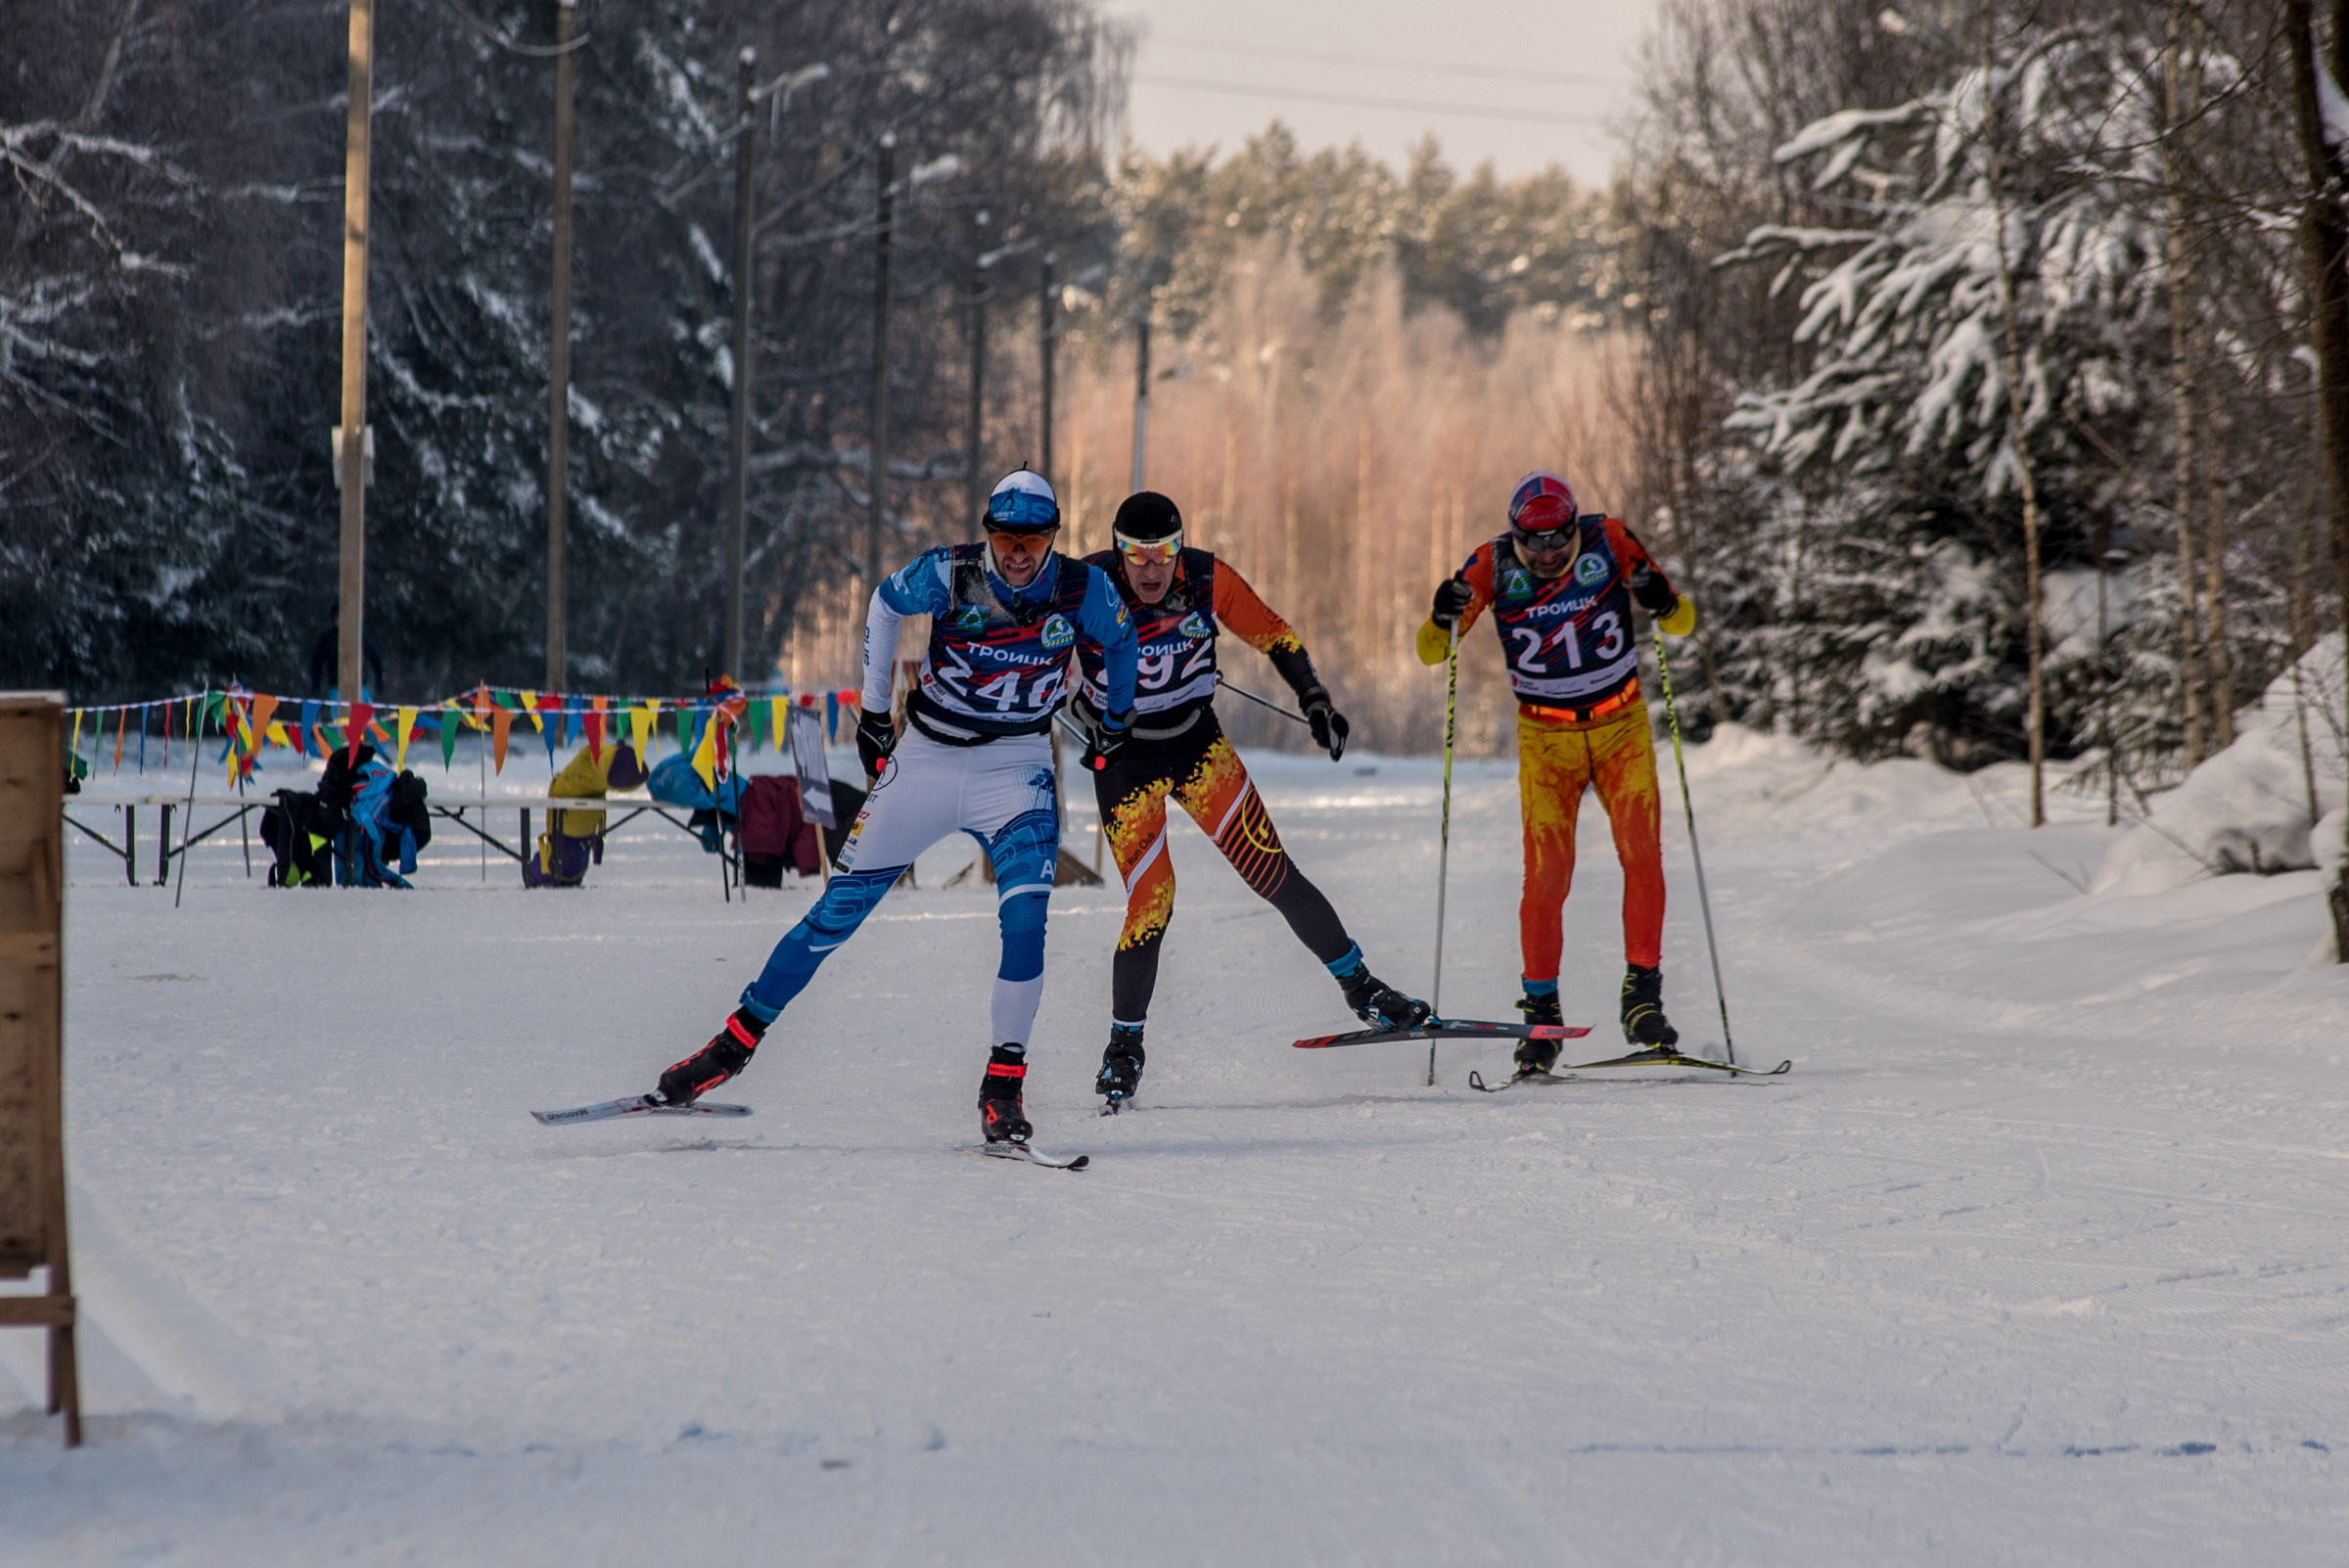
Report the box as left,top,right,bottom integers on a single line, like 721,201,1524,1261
1106,0,1654,181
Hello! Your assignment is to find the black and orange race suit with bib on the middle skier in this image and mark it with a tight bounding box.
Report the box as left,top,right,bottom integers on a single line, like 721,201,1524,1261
1081,549,1356,1028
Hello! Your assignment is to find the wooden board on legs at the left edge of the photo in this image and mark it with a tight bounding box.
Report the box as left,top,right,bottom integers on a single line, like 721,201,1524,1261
0,692,82,1449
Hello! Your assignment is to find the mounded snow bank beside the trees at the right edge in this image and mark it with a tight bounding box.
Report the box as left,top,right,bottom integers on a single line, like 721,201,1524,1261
2093,634,2344,895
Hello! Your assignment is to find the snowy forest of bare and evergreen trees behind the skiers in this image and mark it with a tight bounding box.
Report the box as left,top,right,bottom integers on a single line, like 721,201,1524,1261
0,0,2349,798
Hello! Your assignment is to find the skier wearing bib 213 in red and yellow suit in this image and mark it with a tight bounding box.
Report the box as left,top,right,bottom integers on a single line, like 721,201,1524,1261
1419,472,1696,1073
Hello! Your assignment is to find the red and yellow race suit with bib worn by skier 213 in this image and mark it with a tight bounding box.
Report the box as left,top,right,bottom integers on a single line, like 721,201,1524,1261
1419,514,1681,986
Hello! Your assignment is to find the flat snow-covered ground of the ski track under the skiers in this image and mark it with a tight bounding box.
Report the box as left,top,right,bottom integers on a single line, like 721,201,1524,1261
0,732,2349,1568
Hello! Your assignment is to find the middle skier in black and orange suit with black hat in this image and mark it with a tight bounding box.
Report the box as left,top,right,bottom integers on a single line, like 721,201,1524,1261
1071,490,1428,1113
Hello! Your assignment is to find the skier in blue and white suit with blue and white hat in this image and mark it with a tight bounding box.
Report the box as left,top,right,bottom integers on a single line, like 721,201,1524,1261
656,470,1134,1143
